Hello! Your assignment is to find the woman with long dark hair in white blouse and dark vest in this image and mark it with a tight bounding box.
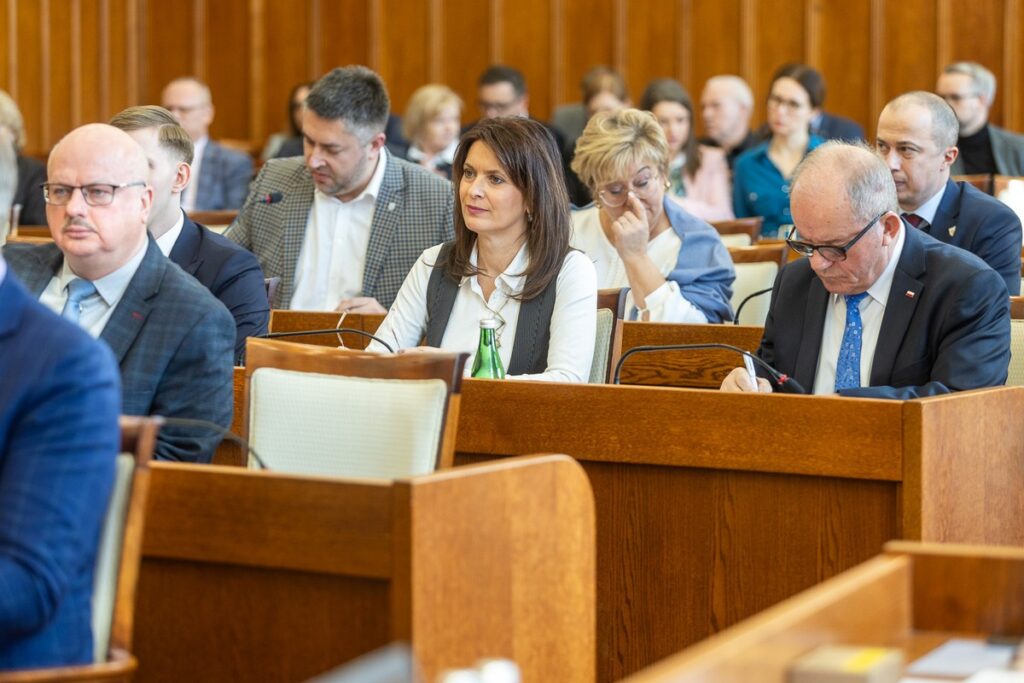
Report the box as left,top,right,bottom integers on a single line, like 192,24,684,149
369,117,597,382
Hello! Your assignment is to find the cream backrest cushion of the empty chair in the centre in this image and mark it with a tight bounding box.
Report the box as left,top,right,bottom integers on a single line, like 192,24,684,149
249,368,447,479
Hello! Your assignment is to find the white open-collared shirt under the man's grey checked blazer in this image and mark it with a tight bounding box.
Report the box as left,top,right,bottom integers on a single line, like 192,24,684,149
290,153,387,310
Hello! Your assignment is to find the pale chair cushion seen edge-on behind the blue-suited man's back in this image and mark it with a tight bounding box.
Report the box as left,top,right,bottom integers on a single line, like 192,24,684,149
92,453,135,664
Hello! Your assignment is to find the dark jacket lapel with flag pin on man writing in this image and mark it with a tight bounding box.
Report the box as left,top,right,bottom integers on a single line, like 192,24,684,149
871,229,925,386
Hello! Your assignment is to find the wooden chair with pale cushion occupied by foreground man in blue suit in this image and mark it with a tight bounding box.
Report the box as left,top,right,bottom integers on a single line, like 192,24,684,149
0,417,160,683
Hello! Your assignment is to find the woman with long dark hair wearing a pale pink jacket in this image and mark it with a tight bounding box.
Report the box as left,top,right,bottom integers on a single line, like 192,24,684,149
640,78,734,221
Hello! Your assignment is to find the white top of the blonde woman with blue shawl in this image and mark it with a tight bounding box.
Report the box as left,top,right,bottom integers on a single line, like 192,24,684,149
572,206,708,323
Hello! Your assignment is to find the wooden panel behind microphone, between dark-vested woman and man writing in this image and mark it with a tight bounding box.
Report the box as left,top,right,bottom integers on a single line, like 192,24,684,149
612,323,764,389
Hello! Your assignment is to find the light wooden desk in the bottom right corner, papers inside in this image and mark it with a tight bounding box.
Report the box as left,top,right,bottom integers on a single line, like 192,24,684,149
628,543,1024,683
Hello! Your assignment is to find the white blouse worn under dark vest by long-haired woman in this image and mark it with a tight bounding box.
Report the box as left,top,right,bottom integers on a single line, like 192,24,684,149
368,245,597,382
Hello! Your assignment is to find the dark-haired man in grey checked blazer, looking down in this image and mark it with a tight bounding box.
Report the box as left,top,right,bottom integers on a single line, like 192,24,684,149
225,67,454,313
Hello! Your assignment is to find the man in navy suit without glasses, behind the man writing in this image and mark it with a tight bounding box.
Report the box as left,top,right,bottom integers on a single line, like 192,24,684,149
876,91,1021,296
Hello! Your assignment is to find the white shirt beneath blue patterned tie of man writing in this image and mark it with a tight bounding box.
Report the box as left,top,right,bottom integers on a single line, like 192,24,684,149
811,226,906,394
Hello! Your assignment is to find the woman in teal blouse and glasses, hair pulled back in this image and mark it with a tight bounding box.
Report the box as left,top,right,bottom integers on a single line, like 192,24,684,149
732,65,824,238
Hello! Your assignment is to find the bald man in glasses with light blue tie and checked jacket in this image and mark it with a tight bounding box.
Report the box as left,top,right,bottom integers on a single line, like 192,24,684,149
4,124,234,462
